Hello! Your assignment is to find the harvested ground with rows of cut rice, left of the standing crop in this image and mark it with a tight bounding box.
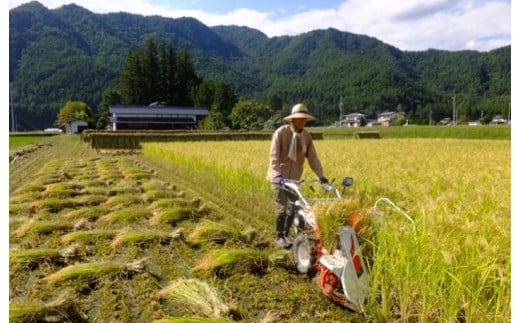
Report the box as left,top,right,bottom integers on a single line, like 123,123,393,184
6,137,358,322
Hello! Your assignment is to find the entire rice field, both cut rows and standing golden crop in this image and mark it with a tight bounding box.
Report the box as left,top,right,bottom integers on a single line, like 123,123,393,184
6,138,511,323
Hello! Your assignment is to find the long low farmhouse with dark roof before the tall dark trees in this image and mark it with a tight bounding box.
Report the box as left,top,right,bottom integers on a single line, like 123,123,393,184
109,102,209,130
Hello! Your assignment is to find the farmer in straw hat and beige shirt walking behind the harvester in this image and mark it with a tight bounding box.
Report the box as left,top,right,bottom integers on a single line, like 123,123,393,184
267,103,328,248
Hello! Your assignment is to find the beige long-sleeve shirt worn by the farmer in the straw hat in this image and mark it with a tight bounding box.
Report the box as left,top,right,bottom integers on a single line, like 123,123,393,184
267,124,324,183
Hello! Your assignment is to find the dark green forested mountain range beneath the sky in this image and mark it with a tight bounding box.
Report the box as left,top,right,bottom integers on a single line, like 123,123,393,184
9,2,511,130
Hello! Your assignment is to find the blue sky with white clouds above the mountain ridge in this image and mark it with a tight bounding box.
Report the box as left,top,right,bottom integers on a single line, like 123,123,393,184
9,0,512,51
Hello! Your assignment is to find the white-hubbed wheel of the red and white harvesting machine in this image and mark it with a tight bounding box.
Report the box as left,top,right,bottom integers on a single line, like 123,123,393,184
293,233,318,276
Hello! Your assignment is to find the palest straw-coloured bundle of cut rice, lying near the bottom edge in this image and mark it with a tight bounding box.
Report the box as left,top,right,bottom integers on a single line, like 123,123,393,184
157,278,229,319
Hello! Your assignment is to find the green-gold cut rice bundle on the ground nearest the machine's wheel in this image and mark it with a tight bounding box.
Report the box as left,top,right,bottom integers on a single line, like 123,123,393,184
194,249,271,276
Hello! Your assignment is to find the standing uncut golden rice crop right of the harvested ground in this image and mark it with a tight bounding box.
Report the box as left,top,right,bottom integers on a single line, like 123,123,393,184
143,139,511,322
